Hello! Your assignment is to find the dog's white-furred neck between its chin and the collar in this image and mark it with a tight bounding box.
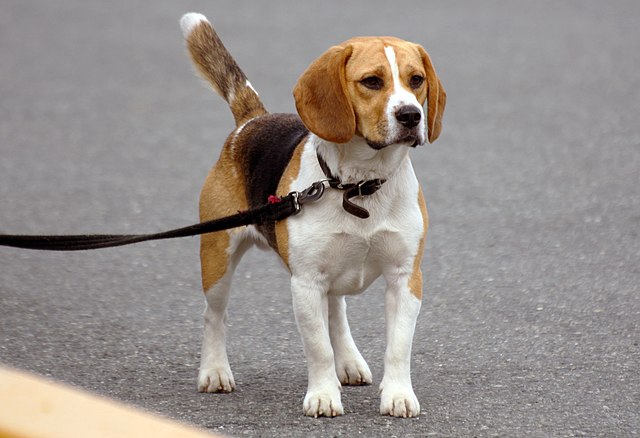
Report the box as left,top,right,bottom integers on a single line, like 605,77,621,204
312,134,409,184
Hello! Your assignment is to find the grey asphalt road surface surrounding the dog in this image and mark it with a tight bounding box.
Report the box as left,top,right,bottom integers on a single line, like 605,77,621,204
0,0,640,437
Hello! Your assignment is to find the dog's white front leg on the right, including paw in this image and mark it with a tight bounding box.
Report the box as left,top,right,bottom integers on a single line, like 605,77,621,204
380,275,421,417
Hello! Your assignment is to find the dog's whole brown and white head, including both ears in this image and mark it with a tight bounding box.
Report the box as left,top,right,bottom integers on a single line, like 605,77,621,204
293,37,446,149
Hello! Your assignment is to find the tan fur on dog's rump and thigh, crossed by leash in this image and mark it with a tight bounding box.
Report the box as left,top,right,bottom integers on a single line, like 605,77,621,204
200,135,248,293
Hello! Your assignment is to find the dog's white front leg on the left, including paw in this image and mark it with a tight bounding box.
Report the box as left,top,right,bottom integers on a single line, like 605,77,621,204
291,276,344,417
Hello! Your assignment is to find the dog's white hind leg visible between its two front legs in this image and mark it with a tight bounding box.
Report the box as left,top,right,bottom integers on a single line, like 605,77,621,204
329,296,372,385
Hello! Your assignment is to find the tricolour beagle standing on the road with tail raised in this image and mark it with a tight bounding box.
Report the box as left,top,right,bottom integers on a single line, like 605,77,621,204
180,13,446,417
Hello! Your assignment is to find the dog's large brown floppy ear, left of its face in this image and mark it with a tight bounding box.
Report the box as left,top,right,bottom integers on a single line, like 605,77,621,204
293,45,356,143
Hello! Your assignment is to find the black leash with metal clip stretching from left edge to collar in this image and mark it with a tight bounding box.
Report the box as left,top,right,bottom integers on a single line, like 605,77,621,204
0,181,324,251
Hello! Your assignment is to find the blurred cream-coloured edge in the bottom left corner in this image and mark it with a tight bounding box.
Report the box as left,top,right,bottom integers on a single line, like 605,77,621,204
0,367,219,438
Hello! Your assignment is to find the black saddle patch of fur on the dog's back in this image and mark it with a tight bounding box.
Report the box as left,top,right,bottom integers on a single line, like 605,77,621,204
236,114,309,246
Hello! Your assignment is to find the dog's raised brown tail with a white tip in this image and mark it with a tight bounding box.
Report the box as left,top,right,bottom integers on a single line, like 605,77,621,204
180,12,267,126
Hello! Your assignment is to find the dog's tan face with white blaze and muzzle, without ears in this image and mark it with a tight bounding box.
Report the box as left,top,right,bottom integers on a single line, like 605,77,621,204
345,38,427,149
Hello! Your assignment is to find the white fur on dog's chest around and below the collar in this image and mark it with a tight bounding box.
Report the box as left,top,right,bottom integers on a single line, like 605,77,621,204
288,140,424,295
